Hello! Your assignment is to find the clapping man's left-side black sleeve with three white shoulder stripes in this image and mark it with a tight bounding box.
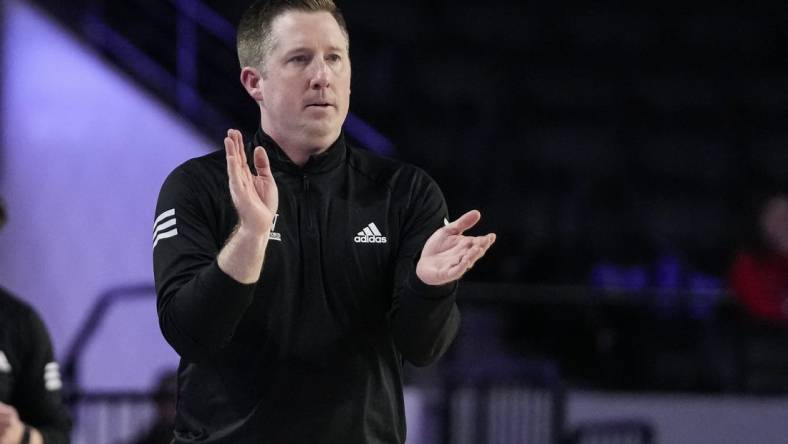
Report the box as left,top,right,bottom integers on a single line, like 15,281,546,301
153,165,254,362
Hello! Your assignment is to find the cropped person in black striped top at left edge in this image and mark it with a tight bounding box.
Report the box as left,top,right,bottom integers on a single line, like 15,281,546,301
0,205,71,444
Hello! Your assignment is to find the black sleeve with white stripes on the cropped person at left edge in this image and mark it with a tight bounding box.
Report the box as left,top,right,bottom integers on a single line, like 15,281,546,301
11,310,71,444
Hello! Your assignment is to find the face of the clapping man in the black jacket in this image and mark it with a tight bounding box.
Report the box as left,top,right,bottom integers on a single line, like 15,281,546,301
261,11,350,150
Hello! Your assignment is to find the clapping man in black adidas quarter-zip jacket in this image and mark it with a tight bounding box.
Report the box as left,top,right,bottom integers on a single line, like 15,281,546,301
153,0,495,443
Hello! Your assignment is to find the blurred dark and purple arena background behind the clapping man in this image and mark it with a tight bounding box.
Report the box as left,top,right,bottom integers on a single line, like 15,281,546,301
0,0,788,444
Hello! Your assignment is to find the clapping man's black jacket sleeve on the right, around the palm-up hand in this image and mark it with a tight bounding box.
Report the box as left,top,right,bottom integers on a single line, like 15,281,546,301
391,173,460,366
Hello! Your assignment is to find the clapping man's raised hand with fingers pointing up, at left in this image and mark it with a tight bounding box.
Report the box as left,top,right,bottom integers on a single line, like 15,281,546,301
224,129,279,236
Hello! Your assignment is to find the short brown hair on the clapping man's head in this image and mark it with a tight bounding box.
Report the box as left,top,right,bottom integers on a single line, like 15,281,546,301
236,0,350,68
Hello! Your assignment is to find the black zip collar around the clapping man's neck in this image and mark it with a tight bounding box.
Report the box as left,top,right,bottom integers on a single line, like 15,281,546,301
246,128,347,175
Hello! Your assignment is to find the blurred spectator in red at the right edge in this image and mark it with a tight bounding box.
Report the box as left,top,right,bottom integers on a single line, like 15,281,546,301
730,194,788,323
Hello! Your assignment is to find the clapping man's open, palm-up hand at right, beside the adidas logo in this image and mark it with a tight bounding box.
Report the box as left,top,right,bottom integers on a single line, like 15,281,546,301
416,210,495,285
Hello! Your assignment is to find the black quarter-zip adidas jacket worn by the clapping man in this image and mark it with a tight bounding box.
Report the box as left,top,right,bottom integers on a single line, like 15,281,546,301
153,126,459,444
